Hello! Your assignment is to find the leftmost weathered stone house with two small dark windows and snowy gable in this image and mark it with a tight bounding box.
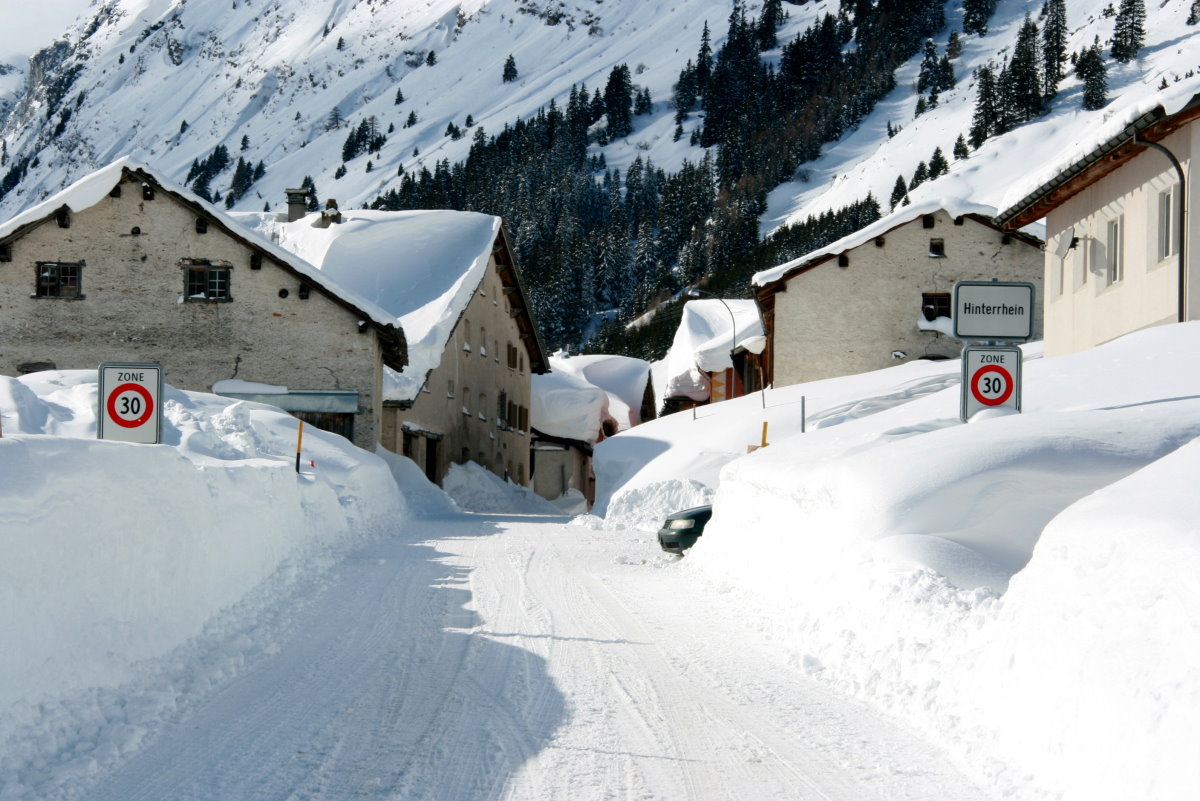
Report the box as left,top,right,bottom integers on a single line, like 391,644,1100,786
0,159,407,447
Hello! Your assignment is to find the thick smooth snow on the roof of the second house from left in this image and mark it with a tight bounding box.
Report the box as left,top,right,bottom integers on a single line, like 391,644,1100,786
238,210,511,402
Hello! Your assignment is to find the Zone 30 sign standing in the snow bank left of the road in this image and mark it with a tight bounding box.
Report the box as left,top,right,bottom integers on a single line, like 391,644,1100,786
96,362,162,445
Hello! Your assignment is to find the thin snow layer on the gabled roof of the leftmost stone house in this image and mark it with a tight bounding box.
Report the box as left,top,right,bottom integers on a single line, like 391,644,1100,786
0,157,396,335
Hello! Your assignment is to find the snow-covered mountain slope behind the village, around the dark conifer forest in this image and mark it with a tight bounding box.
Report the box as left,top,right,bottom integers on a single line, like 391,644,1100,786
0,0,1200,268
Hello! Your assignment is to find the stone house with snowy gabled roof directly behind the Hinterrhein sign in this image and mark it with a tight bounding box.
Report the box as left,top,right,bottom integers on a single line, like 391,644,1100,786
754,203,1042,387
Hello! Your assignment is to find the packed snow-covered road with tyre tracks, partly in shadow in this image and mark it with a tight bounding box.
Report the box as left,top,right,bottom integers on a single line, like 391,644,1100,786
85,516,988,801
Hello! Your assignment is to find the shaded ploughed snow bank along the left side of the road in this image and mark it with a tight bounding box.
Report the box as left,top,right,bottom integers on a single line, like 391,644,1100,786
0,371,410,714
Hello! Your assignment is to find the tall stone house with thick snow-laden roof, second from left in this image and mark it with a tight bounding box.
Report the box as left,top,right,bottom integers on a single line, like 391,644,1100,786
236,210,550,486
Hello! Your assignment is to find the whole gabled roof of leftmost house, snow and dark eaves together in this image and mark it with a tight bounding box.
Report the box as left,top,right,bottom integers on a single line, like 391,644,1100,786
0,157,408,369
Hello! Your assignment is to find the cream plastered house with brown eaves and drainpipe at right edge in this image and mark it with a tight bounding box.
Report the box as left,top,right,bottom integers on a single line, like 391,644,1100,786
998,89,1200,356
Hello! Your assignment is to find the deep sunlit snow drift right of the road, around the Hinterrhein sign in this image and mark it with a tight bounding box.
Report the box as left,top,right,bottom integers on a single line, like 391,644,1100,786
596,323,1200,801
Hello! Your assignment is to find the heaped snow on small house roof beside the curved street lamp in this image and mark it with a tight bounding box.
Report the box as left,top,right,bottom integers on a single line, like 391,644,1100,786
664,300,766,401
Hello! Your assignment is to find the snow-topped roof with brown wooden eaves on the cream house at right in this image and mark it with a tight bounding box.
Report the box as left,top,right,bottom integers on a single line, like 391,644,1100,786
996,88,1200,228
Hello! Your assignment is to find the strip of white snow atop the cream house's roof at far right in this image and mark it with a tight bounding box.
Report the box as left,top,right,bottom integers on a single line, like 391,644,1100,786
1000,87,1200,224
